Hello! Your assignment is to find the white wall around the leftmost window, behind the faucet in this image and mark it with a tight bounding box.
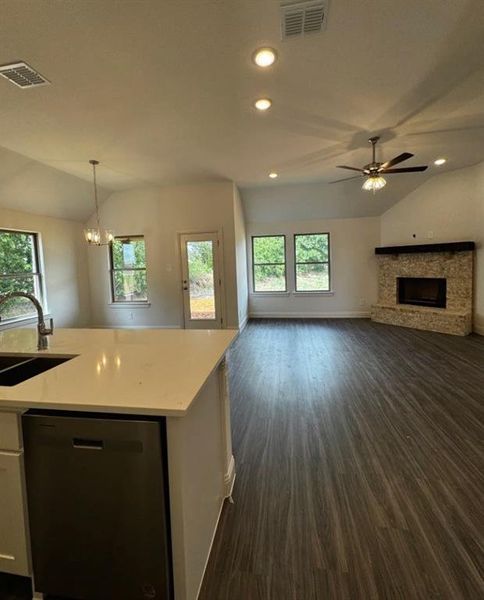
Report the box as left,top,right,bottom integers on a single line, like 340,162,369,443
0,208,90,327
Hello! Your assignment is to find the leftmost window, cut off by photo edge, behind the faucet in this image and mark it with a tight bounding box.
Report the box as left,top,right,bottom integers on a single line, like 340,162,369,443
0,229,43,320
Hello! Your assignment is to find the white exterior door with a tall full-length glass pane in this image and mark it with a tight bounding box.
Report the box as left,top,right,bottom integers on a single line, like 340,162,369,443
180,233,222,329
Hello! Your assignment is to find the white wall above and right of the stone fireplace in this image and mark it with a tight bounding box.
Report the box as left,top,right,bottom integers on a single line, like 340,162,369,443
381,163,484,334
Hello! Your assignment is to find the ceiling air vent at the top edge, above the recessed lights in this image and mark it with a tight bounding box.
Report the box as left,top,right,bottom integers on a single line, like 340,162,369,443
281,0,327,39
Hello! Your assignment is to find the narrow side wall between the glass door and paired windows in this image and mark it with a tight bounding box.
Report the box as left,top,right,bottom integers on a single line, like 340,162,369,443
234,185,249,328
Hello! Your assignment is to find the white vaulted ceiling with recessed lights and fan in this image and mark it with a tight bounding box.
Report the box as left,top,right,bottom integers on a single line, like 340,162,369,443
0,0,484,219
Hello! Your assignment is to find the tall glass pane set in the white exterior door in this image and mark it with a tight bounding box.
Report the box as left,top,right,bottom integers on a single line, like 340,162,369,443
187,240,216,320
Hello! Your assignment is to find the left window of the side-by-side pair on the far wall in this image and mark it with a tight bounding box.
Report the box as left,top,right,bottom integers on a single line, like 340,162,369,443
252,235,286,292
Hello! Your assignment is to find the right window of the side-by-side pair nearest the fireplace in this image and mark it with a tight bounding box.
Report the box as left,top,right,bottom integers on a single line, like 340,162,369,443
294,233,331,292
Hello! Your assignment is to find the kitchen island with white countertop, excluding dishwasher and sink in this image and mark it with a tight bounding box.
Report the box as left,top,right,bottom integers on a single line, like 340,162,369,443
0,329,237,600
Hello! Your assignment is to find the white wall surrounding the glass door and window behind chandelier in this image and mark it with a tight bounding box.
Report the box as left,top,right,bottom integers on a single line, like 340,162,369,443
88,182,238,328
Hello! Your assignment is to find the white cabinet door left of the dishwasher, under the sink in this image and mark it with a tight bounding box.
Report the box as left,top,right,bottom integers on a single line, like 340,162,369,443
0,452,30,576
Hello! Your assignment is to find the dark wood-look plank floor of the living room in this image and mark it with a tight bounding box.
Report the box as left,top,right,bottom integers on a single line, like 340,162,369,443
200,320,484,600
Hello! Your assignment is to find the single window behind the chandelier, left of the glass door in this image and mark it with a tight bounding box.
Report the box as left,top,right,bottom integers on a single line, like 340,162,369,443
109,235,148,302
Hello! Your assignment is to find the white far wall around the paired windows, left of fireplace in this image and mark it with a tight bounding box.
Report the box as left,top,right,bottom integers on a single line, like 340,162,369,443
247,217,380,317
